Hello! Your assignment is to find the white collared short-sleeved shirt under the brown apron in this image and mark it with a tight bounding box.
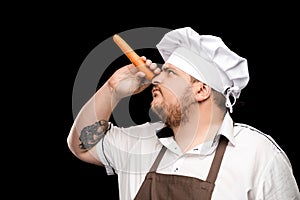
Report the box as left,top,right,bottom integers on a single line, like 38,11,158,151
97,113,300,200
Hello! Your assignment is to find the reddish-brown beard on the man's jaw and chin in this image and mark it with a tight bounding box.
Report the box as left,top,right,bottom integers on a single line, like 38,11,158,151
151,89,198,127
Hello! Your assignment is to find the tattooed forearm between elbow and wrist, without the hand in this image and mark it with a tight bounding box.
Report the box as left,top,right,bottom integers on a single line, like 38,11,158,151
67,83,119,162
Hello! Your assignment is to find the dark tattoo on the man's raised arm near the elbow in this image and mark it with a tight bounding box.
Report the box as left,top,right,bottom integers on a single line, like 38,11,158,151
79,120,110,149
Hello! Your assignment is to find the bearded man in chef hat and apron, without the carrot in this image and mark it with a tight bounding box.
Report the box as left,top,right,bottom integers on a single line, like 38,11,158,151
68,27,300,200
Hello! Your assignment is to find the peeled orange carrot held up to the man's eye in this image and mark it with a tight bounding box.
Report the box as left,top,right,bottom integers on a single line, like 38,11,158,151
113,34,154,80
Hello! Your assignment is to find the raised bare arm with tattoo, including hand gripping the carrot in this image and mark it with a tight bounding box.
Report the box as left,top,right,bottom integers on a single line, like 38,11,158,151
67,57,160,166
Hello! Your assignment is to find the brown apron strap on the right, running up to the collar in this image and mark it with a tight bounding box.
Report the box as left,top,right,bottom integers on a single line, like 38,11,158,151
206,135,228,183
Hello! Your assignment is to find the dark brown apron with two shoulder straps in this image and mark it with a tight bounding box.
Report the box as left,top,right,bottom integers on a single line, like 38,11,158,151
135,136,228,200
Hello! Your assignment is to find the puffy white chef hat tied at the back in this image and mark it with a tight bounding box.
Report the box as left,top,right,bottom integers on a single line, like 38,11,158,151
156,27,249,112
